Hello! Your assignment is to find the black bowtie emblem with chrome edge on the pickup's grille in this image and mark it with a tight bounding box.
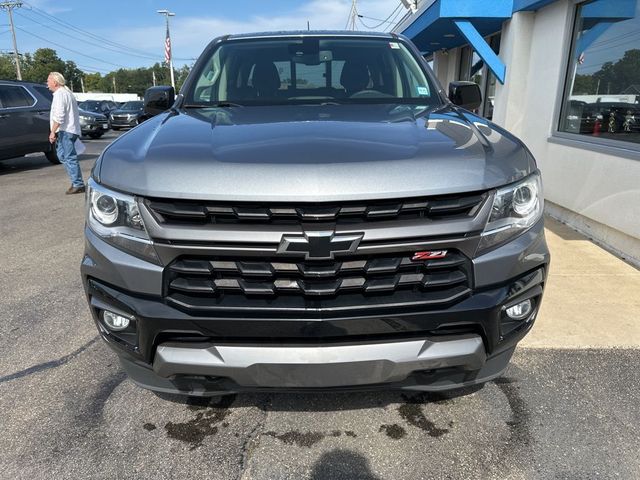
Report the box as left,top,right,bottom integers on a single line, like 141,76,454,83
278,231,364,260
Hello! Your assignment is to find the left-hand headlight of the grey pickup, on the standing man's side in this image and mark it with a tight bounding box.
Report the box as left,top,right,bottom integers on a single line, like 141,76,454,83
87,178,160,264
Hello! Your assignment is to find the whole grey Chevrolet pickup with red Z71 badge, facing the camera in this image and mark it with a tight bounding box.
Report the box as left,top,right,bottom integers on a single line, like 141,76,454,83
81,32,549,395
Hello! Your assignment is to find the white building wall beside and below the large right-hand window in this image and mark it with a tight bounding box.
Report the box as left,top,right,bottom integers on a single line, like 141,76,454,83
493,0,640,262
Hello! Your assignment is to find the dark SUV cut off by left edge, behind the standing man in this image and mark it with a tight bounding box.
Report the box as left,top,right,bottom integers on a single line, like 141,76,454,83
0,80,60,164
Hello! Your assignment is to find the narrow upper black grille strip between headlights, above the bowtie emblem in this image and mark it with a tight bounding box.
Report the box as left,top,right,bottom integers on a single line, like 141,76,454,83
145,194,486,225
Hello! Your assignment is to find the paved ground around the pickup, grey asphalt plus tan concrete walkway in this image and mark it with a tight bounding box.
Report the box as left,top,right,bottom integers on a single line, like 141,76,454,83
0,132,640,480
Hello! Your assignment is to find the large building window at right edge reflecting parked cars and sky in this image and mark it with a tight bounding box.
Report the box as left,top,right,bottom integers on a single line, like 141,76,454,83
559,0,640,144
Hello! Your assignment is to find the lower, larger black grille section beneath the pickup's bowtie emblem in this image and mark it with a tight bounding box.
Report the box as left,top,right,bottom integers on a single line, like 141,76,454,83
166,251,471,309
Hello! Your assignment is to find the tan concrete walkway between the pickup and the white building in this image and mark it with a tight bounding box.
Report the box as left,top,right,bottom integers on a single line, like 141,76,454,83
521,217,640,349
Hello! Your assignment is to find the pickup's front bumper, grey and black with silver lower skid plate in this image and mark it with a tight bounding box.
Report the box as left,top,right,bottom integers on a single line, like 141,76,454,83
82,221,549,395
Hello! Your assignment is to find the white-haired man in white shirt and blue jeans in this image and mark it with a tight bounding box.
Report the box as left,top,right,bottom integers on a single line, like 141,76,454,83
47,72,84,195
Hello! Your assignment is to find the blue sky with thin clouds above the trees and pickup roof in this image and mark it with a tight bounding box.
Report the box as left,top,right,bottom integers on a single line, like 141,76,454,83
0,0,406,74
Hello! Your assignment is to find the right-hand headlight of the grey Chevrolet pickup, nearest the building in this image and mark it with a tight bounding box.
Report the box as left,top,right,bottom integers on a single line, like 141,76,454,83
478,172,544,252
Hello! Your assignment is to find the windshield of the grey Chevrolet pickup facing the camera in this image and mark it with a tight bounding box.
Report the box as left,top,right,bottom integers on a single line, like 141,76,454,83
185,37,441,107
